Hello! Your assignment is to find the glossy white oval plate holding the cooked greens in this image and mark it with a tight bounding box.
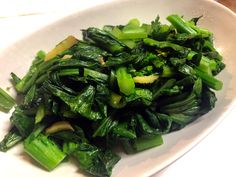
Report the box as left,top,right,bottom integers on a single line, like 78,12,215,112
0,0,236,177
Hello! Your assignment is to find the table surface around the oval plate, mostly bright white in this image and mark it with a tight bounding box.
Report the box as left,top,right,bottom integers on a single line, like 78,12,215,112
0,0,236,177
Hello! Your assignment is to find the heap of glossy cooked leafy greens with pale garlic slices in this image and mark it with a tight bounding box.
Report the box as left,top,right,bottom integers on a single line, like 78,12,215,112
0,15,225,177
